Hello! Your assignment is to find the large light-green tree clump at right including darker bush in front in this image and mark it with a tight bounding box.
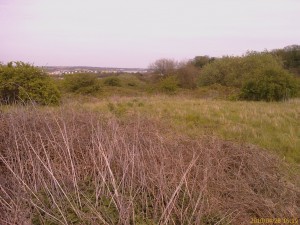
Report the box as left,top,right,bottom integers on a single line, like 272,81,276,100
199,52,298,101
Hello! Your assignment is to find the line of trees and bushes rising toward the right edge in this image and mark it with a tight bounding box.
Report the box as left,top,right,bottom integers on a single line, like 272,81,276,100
149,45,300,101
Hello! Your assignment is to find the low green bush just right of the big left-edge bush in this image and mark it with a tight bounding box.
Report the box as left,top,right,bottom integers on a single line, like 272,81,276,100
63,73,101,95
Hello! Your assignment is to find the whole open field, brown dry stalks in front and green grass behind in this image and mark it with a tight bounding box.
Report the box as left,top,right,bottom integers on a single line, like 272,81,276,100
0,95,300,225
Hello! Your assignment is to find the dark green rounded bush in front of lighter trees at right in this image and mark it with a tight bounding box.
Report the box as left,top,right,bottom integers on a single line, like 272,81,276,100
241,69,298,101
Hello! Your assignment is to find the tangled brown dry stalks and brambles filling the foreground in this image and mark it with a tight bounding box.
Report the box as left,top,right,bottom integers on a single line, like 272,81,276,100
0,108,300,224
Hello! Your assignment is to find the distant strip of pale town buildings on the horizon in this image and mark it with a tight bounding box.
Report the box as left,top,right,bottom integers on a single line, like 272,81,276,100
42,66,149,76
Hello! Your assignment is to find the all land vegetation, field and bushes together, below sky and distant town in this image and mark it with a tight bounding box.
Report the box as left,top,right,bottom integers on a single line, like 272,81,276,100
0,46,300,225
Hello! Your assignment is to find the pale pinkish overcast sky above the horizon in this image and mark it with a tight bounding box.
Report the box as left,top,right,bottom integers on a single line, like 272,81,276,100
0,0,300,68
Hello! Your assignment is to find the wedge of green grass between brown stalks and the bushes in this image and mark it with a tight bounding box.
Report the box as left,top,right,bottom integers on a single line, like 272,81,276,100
83,95,300,163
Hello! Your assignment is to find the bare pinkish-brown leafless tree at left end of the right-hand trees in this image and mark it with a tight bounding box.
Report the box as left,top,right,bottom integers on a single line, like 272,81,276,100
149,59,178,76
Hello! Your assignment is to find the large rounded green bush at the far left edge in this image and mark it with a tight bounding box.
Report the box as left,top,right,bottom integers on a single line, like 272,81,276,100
0,62,61,105
